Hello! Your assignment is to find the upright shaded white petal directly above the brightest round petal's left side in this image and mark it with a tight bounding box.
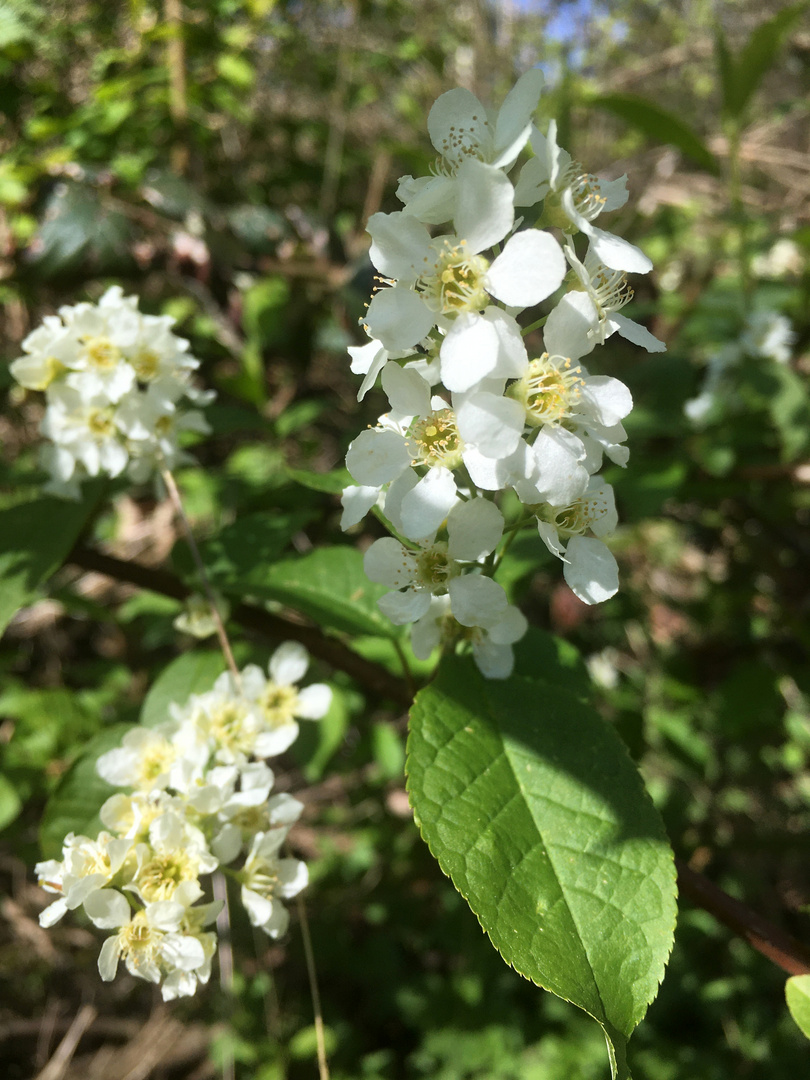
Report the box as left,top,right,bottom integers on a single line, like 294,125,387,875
453,158,515,255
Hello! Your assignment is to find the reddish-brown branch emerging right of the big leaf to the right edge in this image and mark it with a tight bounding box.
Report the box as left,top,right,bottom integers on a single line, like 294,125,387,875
675,859,810,975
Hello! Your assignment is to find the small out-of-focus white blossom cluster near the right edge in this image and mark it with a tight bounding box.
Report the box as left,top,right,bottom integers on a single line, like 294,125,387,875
684,309,796,428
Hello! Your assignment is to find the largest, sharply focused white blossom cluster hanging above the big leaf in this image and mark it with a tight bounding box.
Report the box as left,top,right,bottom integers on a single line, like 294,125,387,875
342,69,664,678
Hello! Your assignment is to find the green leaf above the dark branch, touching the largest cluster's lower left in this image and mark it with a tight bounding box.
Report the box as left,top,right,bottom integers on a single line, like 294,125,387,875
237,545,401,638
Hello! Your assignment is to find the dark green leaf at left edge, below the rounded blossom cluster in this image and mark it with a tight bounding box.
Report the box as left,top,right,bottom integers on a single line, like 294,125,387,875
0,485,100,633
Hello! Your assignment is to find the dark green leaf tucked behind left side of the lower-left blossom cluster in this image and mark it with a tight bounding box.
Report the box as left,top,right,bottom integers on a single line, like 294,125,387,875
39,724,132,859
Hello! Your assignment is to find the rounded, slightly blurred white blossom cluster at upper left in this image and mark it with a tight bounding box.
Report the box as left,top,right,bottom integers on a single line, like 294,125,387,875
11,285,214,498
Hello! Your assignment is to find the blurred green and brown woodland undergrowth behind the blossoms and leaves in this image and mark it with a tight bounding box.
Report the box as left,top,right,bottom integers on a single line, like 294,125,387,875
0,0,810,1080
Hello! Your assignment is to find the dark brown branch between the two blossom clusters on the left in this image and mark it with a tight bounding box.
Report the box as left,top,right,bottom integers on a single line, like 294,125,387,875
67,544,413,705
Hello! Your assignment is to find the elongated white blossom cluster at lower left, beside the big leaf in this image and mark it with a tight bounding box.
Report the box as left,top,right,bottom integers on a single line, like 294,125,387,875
37,643,332,1000
